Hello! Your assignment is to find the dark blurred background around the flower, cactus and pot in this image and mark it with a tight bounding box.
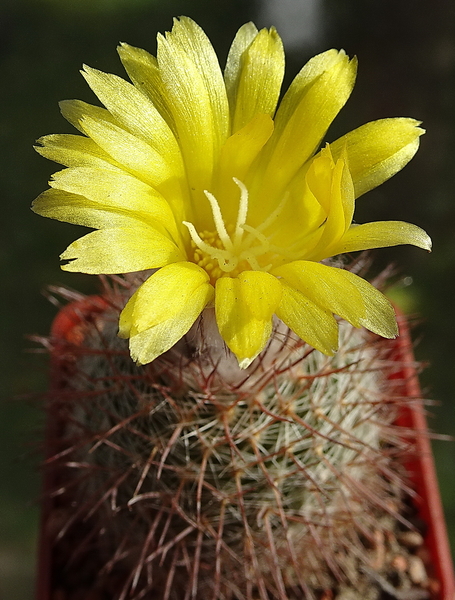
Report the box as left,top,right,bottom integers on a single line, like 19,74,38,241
0,0,455,600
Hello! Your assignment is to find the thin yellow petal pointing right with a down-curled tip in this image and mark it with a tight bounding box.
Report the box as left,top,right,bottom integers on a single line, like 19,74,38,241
318,221,431,260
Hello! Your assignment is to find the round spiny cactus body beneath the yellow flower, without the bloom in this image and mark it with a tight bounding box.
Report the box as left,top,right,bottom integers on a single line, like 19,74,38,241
42,278,414,600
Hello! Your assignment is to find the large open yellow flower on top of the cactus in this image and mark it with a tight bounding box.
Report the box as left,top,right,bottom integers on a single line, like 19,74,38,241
33,17,431,368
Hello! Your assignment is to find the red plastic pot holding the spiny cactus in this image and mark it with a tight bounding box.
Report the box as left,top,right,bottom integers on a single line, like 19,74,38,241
36,296,455,600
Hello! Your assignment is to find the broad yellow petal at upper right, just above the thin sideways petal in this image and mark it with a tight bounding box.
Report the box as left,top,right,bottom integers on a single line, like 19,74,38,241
330,118,425,198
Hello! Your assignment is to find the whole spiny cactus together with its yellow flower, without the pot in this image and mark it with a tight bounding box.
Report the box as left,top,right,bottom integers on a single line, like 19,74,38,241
33,18,431,600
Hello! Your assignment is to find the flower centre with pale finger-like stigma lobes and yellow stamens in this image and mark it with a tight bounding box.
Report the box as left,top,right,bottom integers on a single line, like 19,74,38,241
183,177,272,281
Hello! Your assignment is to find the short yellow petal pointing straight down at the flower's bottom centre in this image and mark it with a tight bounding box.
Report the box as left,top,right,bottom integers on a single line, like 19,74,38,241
215,271,281,369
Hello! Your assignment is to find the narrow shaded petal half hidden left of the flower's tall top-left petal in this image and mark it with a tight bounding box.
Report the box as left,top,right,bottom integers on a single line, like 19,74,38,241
117,42,176,133
